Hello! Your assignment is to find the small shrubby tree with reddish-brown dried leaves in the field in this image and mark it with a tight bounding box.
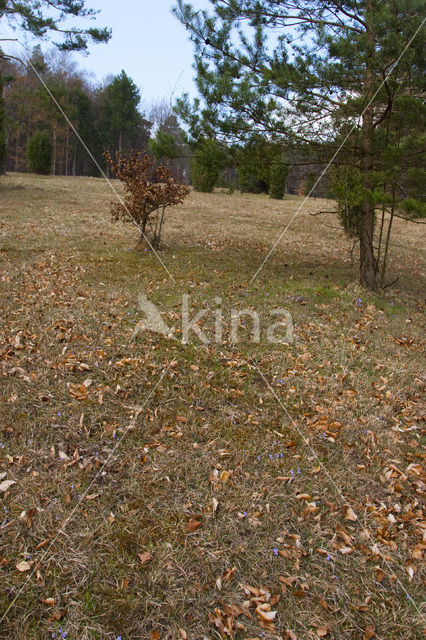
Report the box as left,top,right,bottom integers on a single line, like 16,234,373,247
105,151,190,248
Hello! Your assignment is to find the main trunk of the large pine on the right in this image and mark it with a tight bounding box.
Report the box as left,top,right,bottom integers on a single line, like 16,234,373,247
359,0,377,291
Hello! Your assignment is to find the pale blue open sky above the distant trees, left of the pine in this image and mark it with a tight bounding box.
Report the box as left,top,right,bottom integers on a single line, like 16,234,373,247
4,0,211,104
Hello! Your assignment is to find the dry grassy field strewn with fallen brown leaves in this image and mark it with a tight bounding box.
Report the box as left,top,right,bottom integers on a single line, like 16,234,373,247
0,175,426,640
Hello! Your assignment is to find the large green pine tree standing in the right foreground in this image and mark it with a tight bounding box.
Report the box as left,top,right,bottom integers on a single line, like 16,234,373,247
175,0,425,290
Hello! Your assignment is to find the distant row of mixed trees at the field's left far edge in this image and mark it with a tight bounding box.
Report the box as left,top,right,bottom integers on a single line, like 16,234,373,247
1,46,191,176
